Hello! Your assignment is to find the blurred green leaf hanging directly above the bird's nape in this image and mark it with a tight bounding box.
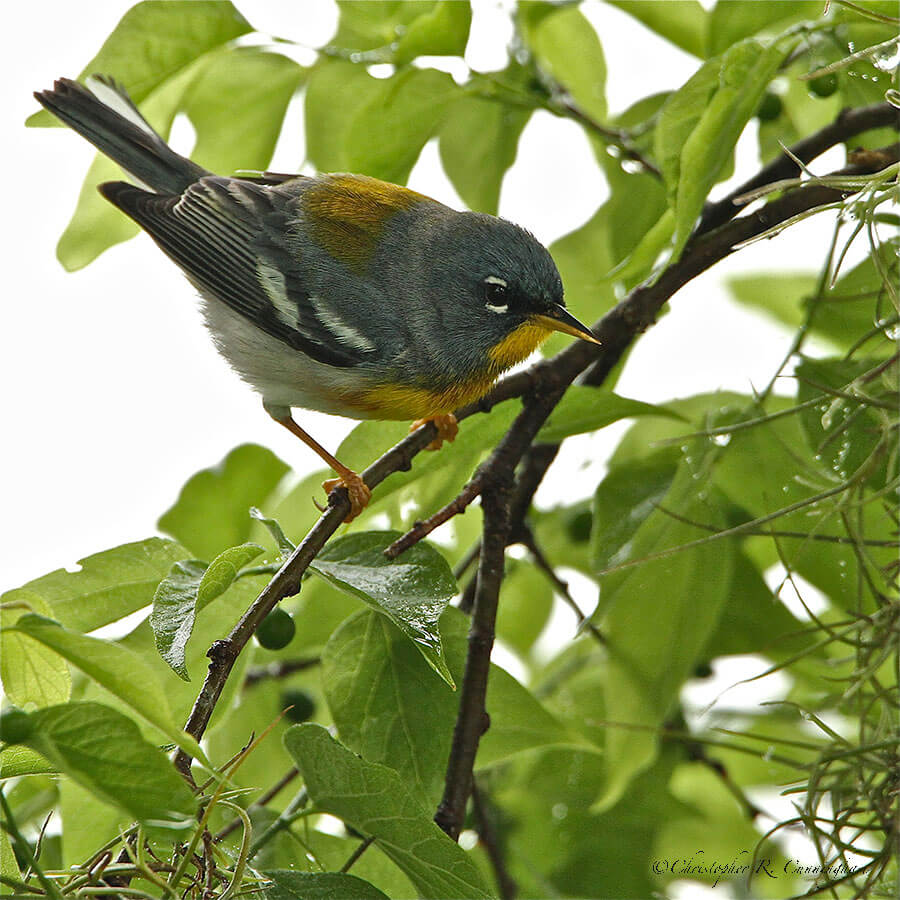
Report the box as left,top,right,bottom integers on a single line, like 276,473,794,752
439,97,531,215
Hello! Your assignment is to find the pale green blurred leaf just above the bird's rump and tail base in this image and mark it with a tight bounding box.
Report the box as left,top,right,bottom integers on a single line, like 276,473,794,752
182,47,304,175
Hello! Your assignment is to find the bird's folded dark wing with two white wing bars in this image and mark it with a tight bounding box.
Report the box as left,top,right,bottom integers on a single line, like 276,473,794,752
100,176,367,368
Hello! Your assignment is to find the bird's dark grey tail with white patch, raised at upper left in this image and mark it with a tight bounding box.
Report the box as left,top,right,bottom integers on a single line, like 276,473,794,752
34,75,210,194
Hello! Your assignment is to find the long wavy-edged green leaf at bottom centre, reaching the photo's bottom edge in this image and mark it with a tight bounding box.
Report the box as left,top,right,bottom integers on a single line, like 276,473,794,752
284,725,491,900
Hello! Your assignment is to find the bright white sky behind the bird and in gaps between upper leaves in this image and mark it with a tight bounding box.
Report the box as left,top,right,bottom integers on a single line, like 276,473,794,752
0,0,844,590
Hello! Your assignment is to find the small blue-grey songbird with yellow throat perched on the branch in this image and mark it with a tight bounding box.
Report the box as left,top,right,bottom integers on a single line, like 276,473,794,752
35,76,599,521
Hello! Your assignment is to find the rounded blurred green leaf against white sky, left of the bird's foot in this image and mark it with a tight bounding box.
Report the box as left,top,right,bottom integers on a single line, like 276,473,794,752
159,444,288,559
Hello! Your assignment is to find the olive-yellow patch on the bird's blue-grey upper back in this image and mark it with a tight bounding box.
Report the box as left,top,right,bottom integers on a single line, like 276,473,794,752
303,175,434,274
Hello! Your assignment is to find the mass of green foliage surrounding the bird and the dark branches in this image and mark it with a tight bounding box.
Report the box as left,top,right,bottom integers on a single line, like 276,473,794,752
0,0,900,900
